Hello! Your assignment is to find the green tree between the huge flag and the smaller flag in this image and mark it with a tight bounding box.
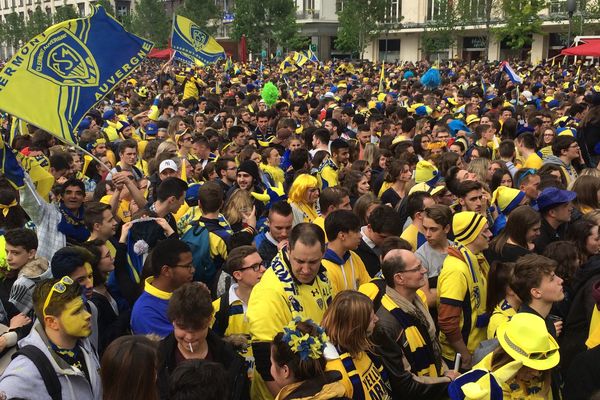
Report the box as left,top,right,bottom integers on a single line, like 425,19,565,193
131,0,171,47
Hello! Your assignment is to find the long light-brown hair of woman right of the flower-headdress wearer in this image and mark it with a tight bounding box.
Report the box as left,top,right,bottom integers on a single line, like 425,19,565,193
321,290,373,357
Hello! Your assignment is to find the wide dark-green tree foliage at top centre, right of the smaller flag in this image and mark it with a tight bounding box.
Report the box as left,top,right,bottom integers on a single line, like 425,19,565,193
232,0,308,54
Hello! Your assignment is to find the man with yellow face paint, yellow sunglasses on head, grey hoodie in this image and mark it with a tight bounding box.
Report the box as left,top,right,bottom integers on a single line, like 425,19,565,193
0,276,102,400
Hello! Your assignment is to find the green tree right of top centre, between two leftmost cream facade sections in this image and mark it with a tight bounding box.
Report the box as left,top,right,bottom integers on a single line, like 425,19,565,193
335,0,390,58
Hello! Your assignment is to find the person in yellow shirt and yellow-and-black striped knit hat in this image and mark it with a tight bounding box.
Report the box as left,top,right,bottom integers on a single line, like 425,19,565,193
437,211,492,369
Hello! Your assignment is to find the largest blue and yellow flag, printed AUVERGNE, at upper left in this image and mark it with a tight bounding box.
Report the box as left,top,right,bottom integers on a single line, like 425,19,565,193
0,7,153,144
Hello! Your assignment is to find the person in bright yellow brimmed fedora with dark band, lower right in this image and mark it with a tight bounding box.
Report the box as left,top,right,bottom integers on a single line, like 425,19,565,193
448,314,560,400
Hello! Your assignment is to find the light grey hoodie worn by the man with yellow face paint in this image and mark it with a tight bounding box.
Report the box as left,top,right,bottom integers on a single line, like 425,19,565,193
0,321,102,400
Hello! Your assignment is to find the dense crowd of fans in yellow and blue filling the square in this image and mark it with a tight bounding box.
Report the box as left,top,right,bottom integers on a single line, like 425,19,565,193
0,55,600,400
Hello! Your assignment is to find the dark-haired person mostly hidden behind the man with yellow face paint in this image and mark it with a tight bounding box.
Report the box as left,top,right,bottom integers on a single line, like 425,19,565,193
50,246,98,349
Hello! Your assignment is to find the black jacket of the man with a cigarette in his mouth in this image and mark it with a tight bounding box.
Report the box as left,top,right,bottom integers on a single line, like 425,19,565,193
156,329,250,400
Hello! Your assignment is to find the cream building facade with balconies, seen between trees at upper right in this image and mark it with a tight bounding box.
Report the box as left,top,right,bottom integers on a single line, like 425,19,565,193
296,0,599,62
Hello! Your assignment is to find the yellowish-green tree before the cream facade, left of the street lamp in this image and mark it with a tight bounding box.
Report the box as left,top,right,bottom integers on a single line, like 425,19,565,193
494,0,547,51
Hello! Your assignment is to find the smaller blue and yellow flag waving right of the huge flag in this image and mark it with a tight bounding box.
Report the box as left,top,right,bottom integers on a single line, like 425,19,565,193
171,15,226,64
